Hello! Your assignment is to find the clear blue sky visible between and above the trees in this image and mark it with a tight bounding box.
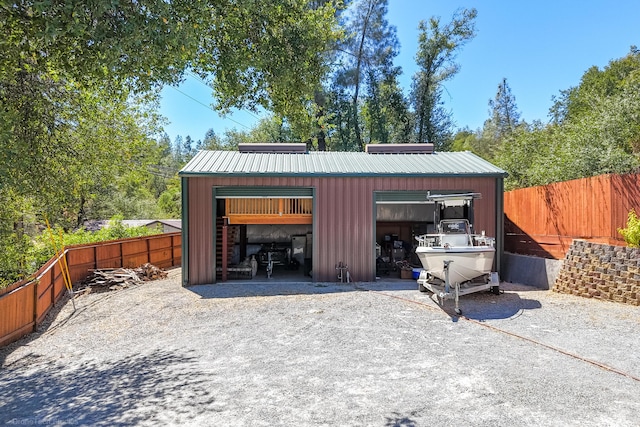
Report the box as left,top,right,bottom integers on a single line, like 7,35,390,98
160,0,640,144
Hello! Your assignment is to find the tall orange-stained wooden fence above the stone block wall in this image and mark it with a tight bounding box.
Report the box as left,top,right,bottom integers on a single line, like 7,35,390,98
504,174,640,259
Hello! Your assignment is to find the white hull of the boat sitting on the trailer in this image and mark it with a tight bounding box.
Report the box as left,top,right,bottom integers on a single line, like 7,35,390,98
416,246,496,285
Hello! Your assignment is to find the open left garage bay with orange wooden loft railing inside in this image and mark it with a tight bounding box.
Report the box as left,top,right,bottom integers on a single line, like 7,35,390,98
216,197,313,281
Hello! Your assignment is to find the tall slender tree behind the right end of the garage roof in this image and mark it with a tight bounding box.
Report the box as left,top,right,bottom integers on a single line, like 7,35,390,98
411,9,477,150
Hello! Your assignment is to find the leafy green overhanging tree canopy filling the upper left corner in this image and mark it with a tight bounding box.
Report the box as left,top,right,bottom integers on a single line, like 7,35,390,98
0,0,338,207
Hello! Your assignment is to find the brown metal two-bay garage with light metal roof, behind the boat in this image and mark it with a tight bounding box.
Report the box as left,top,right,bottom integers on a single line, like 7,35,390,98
179,144,506,286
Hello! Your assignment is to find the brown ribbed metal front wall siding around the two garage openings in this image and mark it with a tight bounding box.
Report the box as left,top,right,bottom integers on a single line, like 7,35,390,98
188,177,496,285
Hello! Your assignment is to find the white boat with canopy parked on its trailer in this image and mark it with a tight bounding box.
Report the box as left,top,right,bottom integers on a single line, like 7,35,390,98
415,193,500,314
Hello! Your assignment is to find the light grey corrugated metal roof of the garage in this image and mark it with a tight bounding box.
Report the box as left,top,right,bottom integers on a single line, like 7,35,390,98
179,151,507,177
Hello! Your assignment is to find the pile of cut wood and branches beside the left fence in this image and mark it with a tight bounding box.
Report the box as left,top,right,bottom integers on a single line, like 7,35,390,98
76,263,167,293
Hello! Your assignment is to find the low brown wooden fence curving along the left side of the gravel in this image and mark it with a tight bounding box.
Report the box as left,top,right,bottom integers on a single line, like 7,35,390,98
0,233,182,347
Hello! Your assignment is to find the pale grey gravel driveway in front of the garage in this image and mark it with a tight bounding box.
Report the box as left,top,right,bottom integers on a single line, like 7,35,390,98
0,270,640,426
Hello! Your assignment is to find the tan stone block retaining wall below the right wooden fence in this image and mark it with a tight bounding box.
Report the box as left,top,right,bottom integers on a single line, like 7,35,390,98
552,240,640,305
